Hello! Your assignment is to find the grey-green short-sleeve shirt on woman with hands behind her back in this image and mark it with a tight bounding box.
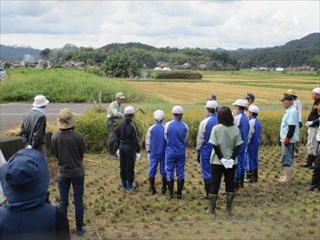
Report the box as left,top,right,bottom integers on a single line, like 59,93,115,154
209,124,243,165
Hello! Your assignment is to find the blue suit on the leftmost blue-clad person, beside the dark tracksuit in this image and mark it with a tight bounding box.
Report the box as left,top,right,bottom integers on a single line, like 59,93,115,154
146,121,166,178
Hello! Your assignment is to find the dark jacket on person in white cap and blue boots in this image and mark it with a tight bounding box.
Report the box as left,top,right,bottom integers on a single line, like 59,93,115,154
115,118,140,153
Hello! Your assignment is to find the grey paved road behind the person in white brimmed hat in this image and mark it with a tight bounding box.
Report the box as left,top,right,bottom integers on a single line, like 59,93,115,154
0,103,108,133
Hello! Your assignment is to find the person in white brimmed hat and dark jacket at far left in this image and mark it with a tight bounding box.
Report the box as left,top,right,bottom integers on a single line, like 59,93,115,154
20,95,49,156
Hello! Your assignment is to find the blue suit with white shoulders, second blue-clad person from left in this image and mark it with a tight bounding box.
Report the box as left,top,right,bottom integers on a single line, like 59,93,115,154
165,118,188,181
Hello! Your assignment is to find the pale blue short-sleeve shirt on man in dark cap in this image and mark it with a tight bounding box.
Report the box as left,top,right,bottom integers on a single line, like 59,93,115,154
280,105,299,143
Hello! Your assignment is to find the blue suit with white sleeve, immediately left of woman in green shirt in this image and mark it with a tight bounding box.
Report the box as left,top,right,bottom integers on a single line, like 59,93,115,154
197,113,218,180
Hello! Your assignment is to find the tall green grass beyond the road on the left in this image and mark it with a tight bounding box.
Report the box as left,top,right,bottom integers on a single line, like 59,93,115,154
1,68,159,102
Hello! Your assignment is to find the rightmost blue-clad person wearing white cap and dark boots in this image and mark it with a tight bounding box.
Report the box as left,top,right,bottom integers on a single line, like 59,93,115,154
247,105,262,182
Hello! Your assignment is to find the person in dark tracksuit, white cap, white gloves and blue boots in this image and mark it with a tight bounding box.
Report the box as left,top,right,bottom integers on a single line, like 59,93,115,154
115,106,141,190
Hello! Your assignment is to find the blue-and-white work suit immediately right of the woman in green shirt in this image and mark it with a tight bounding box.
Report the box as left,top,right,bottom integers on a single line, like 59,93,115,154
235,111,250,182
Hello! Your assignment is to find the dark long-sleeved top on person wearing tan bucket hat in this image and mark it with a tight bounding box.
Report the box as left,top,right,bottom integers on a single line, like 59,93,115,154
51,130,85,177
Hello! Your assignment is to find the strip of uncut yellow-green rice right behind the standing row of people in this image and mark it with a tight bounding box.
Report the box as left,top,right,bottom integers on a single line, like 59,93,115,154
77,108,308,152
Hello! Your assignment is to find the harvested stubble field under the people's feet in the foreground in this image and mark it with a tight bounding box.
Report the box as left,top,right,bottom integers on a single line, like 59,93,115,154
48,146,320,239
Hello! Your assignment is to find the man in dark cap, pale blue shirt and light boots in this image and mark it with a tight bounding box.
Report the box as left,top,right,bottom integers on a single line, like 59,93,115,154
279,95,299,182
